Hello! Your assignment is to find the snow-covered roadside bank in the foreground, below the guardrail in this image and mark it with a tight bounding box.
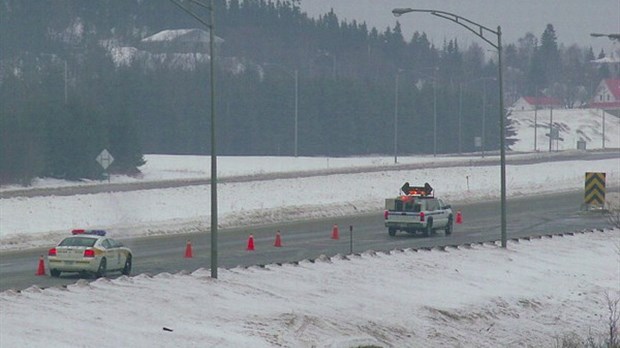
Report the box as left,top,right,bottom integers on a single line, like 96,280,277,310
0,229,620,348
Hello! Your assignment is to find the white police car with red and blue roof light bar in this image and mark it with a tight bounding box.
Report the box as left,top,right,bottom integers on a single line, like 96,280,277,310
47,229,132,278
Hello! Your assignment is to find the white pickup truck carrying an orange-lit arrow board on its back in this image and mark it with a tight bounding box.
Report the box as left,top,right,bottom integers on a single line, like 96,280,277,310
384,183,454,236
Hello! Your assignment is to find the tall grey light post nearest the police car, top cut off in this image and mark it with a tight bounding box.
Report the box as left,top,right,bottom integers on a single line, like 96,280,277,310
170,0,218,278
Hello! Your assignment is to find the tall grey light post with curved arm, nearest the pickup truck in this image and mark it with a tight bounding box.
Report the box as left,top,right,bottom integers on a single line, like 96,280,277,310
392,8,507,248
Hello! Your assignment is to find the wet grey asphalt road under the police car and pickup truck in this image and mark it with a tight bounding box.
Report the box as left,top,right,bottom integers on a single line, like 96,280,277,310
0,189,617,291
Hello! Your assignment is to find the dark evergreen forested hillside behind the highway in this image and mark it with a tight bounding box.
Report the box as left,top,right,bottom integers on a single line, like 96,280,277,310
0,0,607,184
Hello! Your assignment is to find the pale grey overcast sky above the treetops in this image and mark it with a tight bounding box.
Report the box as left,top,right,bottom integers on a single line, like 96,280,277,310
301,0,620,54
